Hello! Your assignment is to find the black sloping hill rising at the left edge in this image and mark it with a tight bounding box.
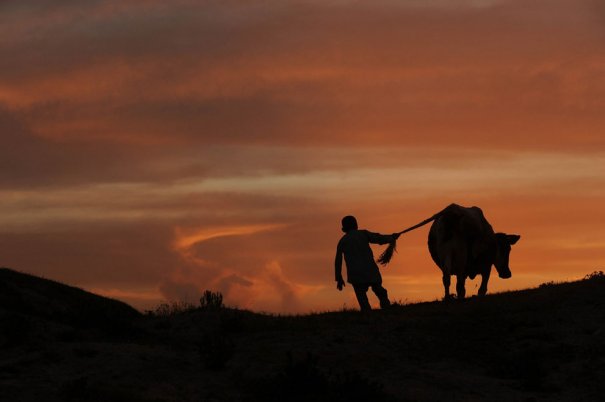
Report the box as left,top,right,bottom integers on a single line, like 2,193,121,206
0,268,140,327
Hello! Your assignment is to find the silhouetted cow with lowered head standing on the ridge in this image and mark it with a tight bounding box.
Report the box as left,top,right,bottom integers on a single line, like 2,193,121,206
428,204,521,299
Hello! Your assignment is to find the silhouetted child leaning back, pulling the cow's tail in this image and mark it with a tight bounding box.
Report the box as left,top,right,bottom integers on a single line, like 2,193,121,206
334,215,399,311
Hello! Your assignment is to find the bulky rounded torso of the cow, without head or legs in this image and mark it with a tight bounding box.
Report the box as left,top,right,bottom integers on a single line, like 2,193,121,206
428,204,496,277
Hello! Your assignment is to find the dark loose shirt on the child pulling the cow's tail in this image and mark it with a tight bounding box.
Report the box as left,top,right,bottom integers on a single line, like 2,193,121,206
335,230,394,284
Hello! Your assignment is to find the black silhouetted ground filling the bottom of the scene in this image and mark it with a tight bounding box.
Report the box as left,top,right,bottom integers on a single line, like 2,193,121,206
0,269,605,402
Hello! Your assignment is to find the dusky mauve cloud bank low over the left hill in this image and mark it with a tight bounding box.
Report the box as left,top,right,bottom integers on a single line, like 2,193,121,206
0,222,181,289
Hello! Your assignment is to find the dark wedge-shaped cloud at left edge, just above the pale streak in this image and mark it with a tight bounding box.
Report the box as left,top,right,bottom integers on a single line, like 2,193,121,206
0,107,212,189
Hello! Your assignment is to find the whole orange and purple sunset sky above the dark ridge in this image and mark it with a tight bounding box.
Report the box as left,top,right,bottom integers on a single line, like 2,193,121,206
0,0,605,313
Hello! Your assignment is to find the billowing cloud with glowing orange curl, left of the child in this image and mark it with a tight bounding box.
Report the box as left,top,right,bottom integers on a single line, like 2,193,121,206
160,217,322,311
